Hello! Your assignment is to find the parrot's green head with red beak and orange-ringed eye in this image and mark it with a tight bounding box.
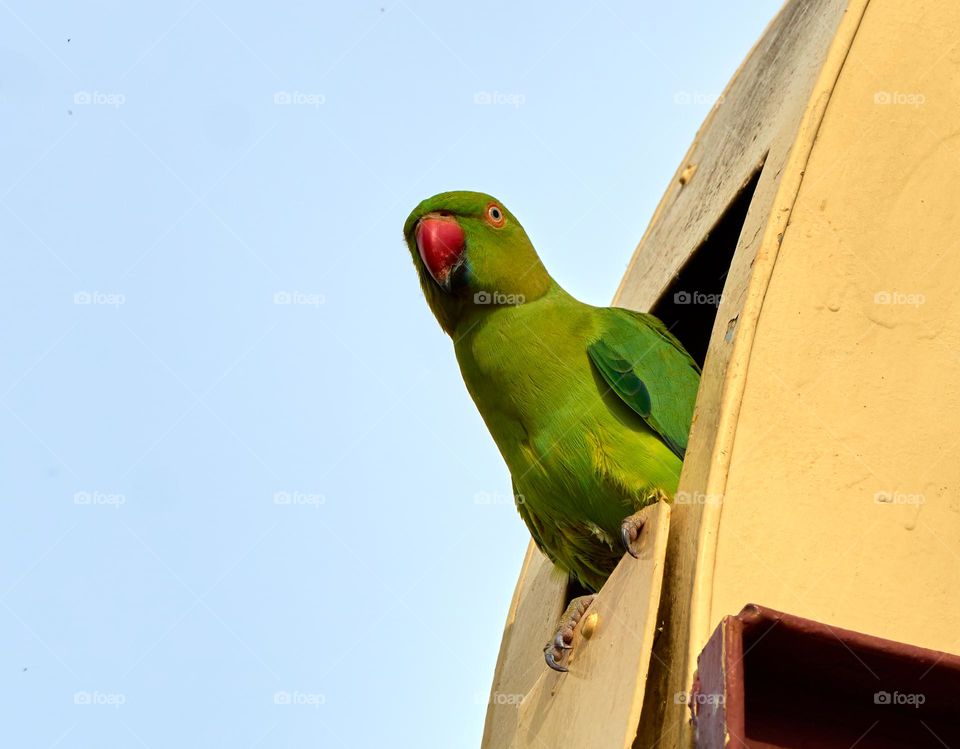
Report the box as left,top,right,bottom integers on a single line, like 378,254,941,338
403,192,553,335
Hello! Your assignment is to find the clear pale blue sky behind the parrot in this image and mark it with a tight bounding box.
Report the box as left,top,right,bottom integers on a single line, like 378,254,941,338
0,0,778,749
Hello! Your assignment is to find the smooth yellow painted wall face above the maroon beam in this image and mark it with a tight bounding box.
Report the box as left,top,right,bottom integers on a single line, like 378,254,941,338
705,0,960,652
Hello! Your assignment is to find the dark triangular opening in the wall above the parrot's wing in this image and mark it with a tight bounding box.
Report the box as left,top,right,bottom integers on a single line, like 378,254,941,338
650,164,763,367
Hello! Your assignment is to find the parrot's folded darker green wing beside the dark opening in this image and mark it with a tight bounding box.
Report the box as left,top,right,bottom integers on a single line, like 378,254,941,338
587,307,700,460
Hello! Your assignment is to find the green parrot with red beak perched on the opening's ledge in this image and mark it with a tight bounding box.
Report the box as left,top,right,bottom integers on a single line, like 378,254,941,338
403,192,700,670
